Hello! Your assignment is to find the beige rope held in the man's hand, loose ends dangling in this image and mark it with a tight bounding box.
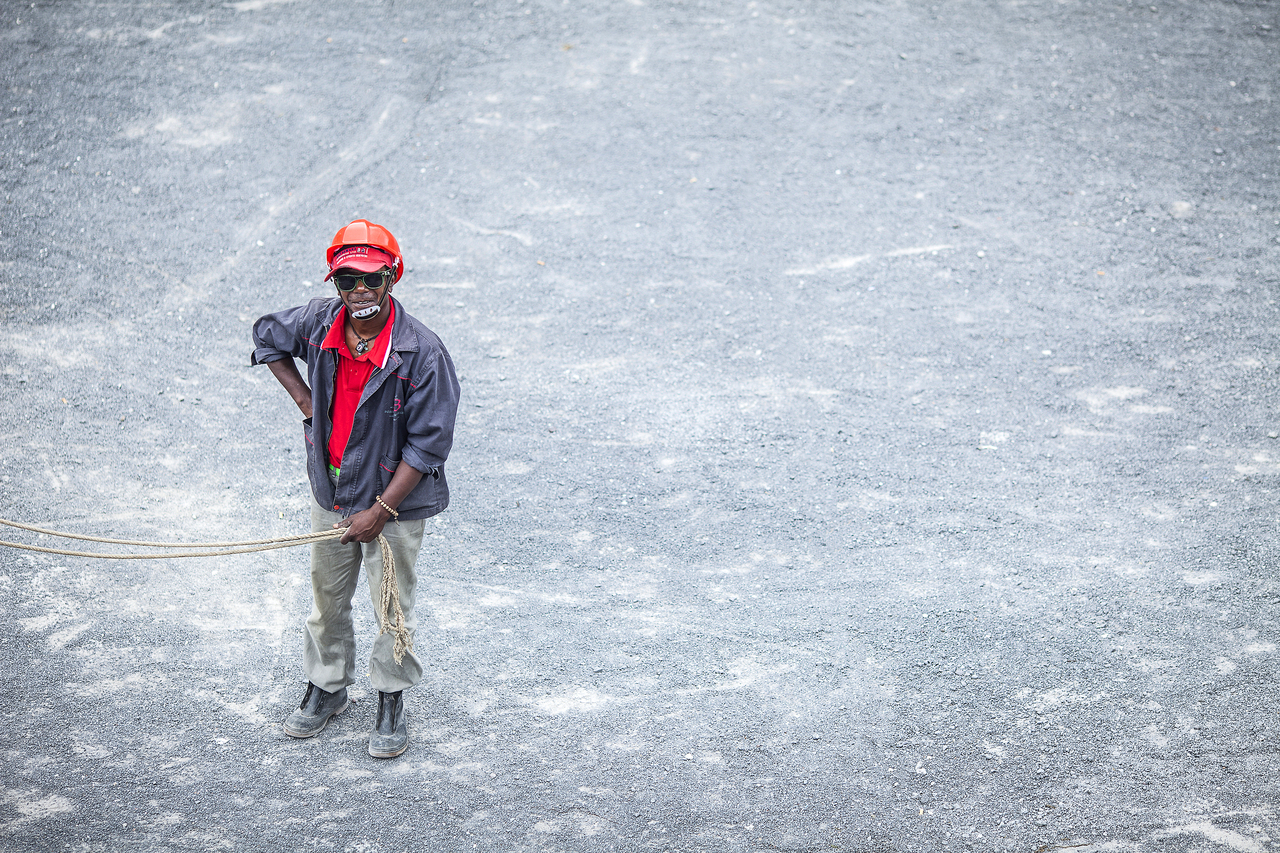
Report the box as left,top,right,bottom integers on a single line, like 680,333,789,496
0,519,413,663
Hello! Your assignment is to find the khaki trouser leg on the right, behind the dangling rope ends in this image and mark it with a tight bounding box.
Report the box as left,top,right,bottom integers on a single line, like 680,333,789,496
365,519,426,693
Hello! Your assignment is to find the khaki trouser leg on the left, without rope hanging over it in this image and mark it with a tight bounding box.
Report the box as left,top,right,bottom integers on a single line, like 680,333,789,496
302,498,361,693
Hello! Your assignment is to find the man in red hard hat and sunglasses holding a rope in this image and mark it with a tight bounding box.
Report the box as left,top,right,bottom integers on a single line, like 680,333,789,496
252,219,458,758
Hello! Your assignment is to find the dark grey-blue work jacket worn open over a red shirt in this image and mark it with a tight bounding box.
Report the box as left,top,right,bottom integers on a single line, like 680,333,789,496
251,297,460,519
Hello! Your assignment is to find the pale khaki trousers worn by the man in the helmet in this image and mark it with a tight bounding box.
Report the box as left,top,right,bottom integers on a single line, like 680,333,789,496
302,498,426,693
